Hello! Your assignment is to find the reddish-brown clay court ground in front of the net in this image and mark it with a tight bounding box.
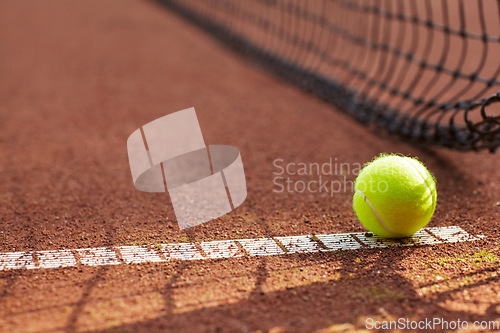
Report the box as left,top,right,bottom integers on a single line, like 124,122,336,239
0,0,500,332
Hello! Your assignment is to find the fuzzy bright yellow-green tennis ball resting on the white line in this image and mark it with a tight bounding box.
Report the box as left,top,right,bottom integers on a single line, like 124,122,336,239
353,155,437,238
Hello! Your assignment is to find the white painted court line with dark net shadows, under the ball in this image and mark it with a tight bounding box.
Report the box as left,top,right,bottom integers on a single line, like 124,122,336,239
0,226,485,271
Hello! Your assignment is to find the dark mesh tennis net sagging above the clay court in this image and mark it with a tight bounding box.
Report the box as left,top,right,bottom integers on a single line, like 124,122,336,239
159,0,500,152
